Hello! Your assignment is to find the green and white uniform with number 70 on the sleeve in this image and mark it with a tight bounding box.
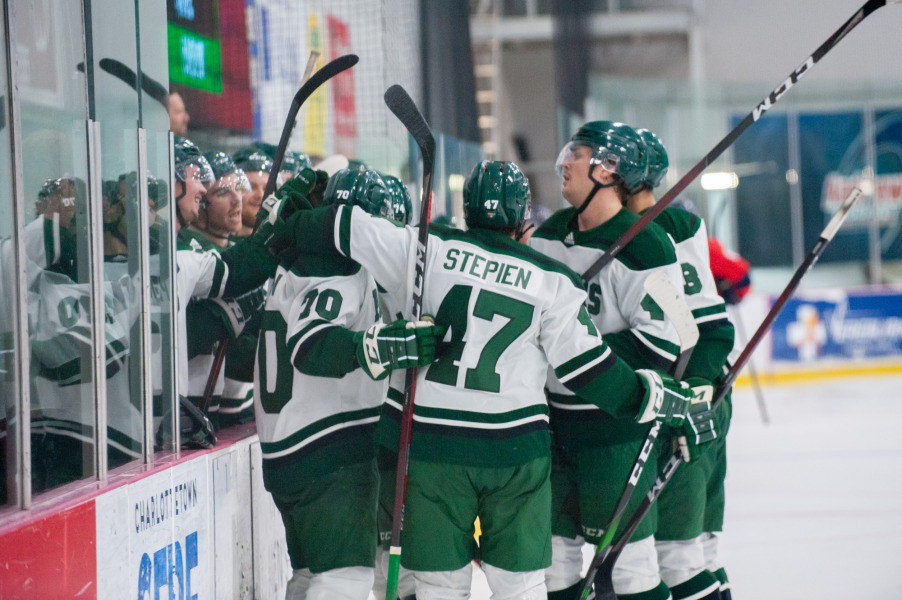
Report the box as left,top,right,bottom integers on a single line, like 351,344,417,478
254,252,387,580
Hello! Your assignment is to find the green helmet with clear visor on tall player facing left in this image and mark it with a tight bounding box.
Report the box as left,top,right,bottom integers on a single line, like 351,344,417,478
555,121,648,190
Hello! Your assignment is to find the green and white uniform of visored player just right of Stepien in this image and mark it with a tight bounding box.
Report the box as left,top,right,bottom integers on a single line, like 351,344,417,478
529,208,681,592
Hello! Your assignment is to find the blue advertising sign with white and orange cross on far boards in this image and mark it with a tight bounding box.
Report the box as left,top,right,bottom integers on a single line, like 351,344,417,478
772,290,902,362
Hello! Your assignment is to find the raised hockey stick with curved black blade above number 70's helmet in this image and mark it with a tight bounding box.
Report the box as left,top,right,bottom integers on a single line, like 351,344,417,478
200,50,359,415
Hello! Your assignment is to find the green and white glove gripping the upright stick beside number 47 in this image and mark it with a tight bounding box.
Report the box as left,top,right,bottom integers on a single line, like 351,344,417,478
354,319,445,380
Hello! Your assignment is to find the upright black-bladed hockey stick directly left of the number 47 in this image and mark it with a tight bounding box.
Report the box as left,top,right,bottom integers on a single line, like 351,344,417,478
385,85,435,600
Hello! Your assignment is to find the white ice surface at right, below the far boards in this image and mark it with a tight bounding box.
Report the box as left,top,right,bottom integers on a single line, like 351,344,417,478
472,376,902,600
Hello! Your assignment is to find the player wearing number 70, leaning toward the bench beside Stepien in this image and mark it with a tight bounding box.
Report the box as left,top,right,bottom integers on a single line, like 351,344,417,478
254,170,441,600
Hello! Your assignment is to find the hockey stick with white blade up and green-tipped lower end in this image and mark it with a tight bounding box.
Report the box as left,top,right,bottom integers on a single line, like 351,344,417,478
579,271,698,599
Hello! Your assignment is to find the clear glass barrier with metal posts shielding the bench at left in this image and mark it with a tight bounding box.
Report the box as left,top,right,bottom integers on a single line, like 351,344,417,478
0,0,175,508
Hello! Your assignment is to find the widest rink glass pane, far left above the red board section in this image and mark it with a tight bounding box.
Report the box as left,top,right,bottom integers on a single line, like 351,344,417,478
11,0,96,494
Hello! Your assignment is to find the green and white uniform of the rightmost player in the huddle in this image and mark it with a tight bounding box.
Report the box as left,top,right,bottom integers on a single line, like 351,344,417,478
655,207,735,599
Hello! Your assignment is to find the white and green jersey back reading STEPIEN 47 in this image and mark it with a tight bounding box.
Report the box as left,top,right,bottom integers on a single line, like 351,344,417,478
335,209,604,466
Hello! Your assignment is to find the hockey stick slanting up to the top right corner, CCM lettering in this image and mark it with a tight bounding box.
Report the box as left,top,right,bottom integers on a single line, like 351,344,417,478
583,0,902,280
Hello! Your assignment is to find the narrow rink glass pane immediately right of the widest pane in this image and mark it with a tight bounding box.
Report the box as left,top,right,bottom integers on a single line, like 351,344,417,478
85,0,146,469
